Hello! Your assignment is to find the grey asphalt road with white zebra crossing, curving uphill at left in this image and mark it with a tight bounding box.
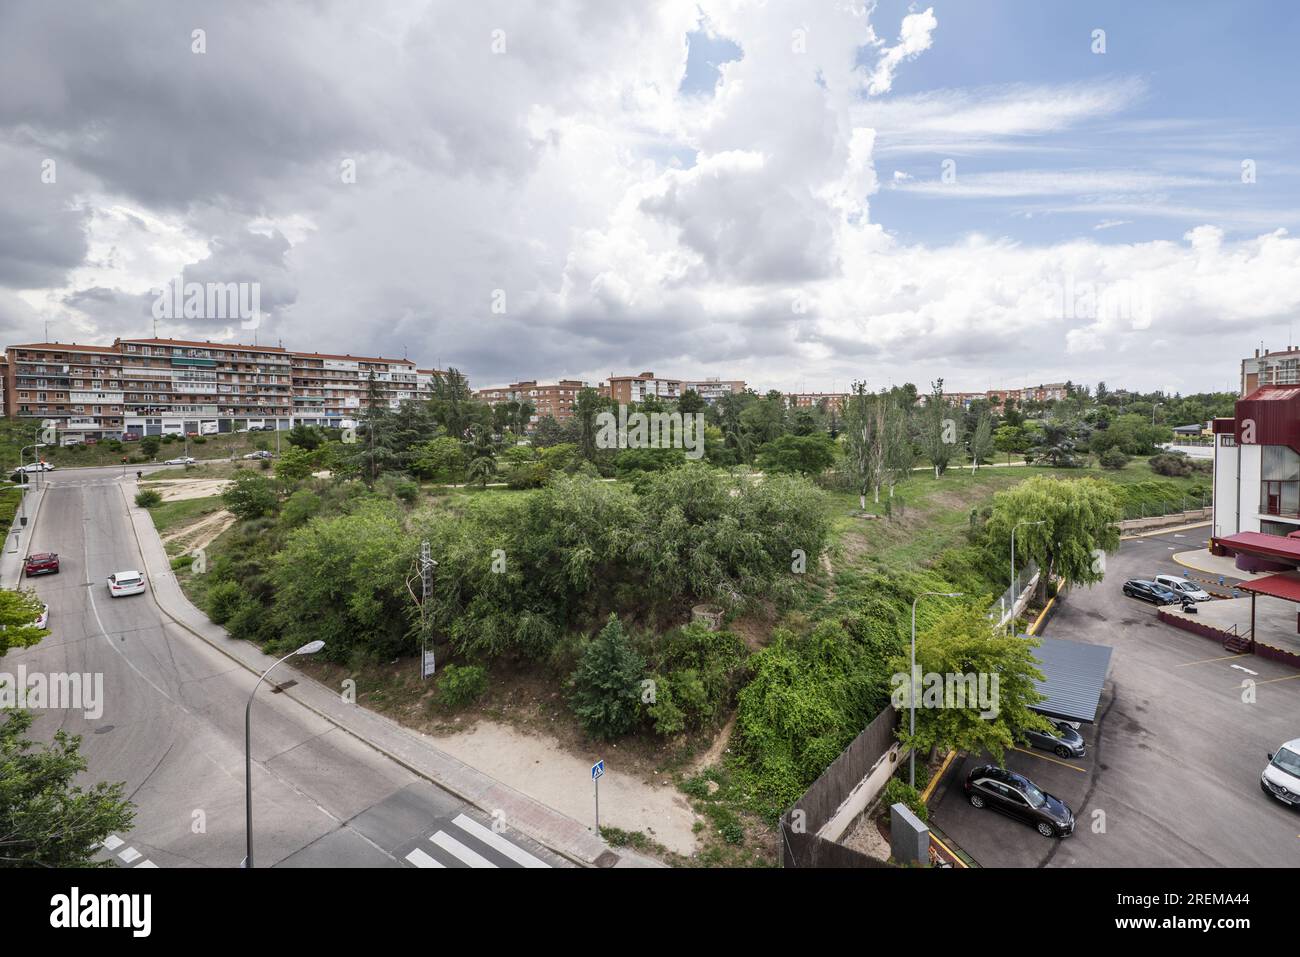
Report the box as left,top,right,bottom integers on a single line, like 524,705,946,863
0,469,566,867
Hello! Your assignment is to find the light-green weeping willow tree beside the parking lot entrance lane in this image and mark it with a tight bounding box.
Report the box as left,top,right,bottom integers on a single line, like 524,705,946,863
985,476,1122,597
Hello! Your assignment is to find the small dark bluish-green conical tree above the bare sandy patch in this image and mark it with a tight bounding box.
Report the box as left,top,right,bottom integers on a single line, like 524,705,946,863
572,614,646,740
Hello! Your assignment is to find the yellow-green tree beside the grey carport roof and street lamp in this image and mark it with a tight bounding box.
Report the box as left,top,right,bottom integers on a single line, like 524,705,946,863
892,605,1050,763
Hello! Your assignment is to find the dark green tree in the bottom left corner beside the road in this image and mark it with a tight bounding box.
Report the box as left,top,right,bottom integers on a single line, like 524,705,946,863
0,710,135,867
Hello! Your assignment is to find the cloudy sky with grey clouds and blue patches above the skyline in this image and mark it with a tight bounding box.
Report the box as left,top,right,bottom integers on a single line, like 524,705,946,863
0,0,1300,393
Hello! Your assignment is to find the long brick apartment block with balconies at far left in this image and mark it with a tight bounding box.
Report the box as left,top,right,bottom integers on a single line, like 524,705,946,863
4,338,452,442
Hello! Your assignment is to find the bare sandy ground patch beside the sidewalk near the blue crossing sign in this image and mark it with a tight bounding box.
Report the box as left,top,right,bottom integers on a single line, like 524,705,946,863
434,722,697,856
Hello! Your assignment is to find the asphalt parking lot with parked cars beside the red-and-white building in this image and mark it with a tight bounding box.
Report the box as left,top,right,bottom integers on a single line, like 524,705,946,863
931,528,1300,867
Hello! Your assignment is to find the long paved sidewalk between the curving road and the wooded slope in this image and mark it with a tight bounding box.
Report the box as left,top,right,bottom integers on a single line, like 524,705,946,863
121,482,664,867
